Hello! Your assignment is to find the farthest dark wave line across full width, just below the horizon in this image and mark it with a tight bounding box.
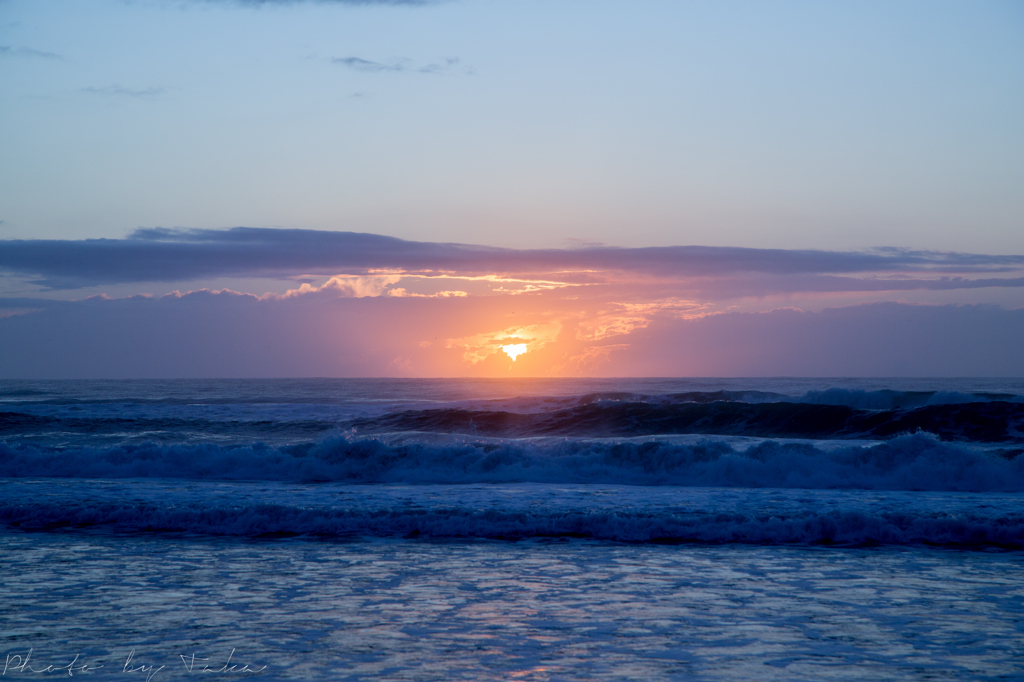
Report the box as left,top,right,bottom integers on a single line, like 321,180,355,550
0,389,1024,445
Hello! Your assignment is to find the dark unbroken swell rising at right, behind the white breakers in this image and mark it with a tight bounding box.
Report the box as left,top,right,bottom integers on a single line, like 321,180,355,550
350,399,1024,442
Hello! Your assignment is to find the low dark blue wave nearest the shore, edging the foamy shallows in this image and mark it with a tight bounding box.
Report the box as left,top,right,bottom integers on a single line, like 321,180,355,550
0,493,1024,549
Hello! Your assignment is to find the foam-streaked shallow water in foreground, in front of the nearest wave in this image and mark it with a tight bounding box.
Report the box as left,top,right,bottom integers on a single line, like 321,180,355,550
0,534,1024,680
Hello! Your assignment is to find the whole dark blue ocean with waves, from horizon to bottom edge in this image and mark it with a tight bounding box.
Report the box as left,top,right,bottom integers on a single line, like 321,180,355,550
0,379,1024,680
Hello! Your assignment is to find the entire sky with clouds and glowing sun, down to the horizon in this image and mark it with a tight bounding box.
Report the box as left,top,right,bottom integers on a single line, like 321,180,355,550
0,0,1024,378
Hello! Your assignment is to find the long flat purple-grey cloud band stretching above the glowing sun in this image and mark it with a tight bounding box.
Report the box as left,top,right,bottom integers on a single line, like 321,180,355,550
0,227,1024,291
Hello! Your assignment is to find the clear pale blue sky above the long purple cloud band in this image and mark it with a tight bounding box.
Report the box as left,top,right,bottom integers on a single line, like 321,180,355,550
0,0,1024,253
